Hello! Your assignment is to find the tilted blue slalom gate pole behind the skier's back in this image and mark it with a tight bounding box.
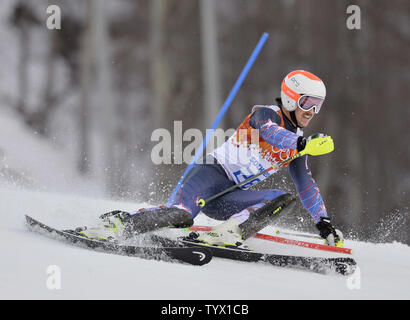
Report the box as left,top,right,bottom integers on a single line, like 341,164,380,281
167,32,269,206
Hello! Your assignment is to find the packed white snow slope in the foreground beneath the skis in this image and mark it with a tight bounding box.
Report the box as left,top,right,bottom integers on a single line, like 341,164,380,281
0,187,410,300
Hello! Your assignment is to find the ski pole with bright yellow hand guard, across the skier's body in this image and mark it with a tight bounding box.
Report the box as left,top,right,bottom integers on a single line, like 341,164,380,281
197,136,334,208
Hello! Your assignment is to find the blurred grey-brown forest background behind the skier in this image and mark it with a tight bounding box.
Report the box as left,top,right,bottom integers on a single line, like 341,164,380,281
2,0,410,243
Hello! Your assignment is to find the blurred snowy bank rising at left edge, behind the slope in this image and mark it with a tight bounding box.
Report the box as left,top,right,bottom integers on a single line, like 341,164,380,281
0,108,104,196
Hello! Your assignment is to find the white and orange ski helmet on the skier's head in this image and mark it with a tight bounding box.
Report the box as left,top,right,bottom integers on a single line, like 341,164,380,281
280,70,326,113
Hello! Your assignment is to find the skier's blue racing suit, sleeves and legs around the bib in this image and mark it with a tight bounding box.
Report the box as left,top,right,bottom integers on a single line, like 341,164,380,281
144,106,327,223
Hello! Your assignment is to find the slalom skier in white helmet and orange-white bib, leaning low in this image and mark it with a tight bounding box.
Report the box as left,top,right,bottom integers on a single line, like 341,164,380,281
77,70,343,246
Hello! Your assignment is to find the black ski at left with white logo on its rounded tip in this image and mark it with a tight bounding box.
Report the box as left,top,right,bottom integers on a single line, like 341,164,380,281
26,215,212,265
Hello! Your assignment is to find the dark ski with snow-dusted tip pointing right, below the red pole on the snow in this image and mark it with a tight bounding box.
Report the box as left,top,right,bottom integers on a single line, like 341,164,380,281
147,235,356,275
